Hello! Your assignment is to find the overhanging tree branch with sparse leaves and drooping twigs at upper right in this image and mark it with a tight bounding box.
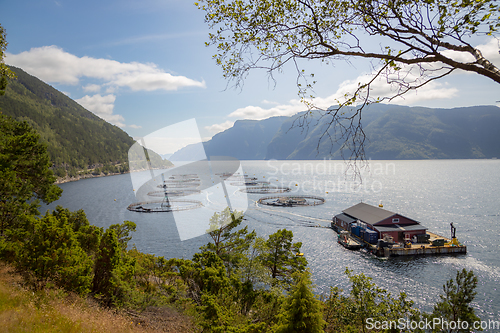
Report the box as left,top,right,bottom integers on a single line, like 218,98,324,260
195,0,500,159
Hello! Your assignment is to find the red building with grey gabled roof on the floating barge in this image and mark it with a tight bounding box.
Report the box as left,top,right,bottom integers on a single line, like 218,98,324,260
333,202,427,242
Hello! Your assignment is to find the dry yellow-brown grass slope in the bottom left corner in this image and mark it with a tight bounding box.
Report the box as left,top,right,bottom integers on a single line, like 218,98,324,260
0,263,195,333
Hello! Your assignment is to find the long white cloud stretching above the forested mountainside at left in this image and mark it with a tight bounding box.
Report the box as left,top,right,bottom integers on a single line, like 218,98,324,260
6,45,205,91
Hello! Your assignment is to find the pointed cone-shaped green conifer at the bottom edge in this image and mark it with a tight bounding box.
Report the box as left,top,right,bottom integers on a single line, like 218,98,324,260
276,271,326,333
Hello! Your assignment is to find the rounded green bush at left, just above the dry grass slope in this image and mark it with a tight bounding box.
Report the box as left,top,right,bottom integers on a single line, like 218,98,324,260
10,212,93,295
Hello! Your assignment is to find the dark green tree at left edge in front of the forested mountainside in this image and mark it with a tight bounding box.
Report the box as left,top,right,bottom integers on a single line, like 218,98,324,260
0,114,62,234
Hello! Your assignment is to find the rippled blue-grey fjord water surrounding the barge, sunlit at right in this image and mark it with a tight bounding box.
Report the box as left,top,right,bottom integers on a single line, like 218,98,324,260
42,160,500,320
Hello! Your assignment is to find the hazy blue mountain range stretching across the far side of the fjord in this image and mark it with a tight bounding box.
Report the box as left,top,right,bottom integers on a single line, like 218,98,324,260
170,104,500,161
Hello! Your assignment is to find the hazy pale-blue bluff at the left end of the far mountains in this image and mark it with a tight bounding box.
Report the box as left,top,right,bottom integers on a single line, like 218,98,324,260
170,117,288,161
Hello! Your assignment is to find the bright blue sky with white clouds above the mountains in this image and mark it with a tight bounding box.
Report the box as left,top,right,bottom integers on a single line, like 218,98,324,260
0,0,500,154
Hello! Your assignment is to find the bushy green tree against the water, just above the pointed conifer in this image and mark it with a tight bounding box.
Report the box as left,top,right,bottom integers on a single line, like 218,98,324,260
261,229,307,288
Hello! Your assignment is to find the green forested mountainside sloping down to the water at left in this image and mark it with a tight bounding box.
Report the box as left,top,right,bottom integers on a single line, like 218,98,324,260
0,67,171,177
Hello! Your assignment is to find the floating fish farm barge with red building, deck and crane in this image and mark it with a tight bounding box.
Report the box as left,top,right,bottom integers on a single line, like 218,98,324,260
331,202,467,257
